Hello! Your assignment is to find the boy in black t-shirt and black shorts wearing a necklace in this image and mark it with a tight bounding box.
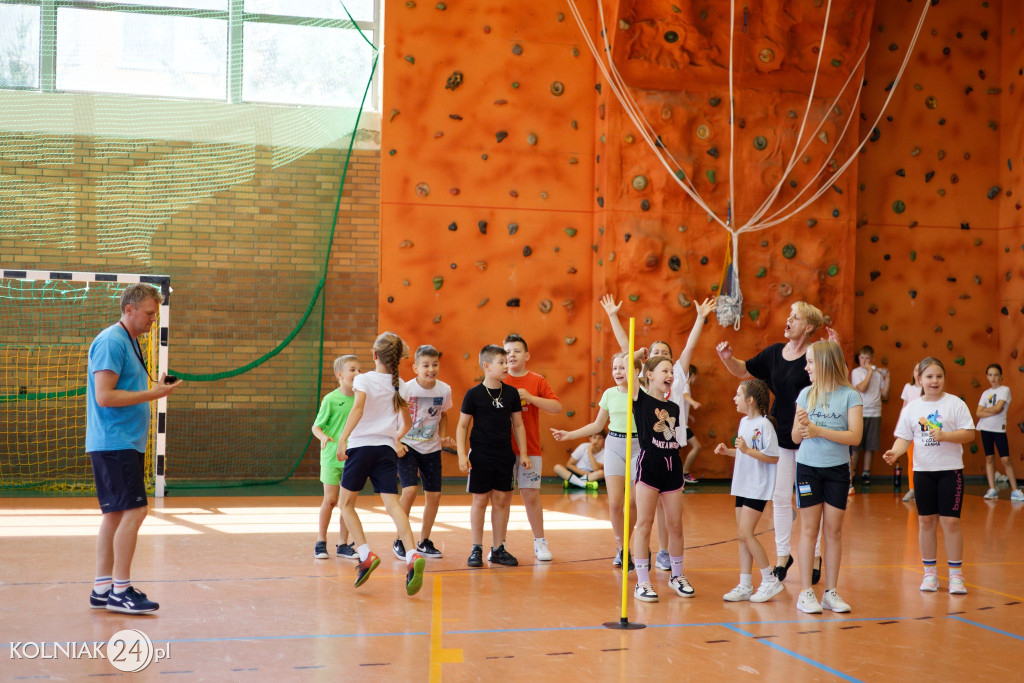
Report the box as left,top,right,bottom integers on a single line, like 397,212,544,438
456,344,532,567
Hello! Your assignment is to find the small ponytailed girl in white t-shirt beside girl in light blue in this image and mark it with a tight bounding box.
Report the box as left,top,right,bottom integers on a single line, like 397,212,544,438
715,380,782,602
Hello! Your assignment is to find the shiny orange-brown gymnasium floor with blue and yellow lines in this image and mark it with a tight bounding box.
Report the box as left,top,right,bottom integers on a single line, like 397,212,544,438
0,485,1024,681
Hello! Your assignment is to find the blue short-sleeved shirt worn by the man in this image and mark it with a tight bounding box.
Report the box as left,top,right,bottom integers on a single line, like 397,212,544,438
85,324,150,453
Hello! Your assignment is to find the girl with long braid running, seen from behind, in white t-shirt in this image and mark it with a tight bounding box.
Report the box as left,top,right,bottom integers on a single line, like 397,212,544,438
338,332,427,595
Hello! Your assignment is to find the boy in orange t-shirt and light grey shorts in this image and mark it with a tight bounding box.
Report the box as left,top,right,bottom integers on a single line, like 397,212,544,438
504,334,562,562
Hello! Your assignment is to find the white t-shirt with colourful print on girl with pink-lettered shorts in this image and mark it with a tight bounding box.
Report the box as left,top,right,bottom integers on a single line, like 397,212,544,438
895,393,974,472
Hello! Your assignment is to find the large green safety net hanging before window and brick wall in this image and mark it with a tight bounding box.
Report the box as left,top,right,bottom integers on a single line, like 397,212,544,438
0,0,378,489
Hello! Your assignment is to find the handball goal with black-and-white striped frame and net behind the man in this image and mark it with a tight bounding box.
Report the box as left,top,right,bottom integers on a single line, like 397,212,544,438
0,269,170,496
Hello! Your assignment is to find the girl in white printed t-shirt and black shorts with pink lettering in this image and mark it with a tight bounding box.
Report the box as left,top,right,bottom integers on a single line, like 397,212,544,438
884,358,974,595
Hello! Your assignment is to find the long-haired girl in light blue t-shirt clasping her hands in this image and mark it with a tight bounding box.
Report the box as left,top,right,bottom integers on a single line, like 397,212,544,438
793,341,864,614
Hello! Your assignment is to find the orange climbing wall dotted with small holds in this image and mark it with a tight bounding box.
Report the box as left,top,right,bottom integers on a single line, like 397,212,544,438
380,0,1024,476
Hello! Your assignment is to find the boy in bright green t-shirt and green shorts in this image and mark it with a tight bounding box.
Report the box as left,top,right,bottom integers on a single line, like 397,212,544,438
312,355,359,560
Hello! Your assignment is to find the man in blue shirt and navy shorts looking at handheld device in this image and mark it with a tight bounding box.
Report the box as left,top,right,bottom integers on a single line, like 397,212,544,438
85,284,182,614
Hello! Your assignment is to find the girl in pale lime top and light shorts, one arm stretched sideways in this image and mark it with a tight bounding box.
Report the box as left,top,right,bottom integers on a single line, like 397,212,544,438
551,353,640,568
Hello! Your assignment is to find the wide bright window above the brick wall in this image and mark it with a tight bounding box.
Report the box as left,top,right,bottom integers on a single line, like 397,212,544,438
0,0,380,109
